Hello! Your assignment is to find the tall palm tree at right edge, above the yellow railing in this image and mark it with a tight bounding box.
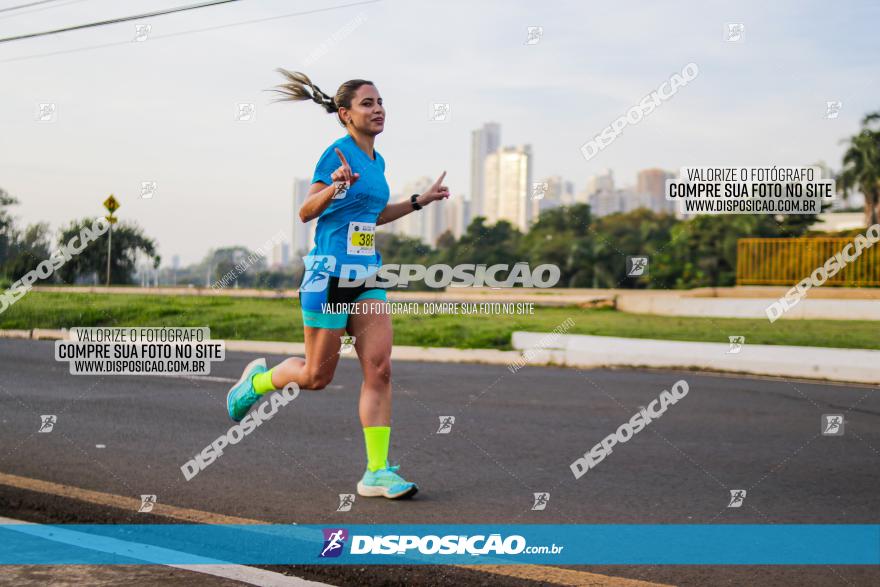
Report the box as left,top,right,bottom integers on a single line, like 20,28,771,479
838,111,880,226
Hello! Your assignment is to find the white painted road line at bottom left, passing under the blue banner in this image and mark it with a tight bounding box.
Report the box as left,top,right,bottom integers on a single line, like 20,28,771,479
0,516,329,587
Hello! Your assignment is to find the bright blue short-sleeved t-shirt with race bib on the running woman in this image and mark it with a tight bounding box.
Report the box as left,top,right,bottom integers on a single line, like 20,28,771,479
309,134,390,277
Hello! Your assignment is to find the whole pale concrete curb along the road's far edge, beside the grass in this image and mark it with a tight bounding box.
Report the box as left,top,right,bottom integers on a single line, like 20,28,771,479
0,328,880,385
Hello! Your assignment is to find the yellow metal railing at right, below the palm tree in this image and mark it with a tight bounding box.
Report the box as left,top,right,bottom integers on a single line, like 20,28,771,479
736,237,880,287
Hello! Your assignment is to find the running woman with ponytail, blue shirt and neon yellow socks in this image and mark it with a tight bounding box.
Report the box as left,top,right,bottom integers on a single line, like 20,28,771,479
226,69,449,499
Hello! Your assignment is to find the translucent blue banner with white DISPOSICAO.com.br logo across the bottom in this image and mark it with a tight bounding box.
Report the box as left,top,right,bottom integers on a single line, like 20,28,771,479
0,524,880,565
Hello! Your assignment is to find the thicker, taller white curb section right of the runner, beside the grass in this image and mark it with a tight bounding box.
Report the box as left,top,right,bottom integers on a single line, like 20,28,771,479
513,332,880,384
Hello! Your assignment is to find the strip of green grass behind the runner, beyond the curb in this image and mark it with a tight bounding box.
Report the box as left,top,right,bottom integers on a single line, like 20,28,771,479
0,292,880,350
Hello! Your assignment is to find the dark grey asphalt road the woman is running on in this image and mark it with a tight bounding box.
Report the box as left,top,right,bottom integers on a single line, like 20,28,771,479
0,340,880,585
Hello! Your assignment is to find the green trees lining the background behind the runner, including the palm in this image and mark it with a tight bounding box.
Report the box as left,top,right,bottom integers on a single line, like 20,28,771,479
0,111,880,289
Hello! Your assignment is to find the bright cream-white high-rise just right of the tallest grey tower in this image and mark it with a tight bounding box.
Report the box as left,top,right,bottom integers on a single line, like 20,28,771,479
482,145,534,232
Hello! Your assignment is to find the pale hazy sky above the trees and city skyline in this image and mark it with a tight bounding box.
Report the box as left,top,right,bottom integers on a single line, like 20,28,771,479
0,0,880,264
